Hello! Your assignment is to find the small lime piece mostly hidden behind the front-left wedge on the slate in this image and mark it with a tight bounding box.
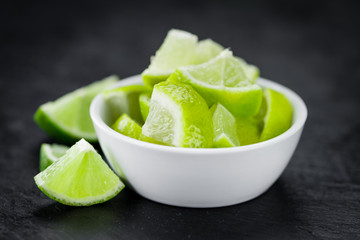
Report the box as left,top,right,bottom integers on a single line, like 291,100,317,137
40,143,69,171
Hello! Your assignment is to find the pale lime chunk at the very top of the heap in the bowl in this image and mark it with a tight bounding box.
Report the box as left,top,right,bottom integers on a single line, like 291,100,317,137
142,29,198,86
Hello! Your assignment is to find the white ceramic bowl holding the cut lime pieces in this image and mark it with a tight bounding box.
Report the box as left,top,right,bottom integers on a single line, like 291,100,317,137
90,75,307,208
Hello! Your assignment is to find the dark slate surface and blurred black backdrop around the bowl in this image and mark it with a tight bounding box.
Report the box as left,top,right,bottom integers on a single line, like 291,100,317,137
0,1,360,239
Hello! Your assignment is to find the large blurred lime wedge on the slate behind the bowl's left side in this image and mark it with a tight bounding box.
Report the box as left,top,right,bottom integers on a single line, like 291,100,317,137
34,76,118,144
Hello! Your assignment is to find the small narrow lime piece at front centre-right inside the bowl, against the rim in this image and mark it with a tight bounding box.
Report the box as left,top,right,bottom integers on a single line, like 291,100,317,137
210,103,240,148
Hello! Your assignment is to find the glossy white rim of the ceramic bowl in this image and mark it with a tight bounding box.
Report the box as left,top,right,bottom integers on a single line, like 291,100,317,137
90,74,308,154
